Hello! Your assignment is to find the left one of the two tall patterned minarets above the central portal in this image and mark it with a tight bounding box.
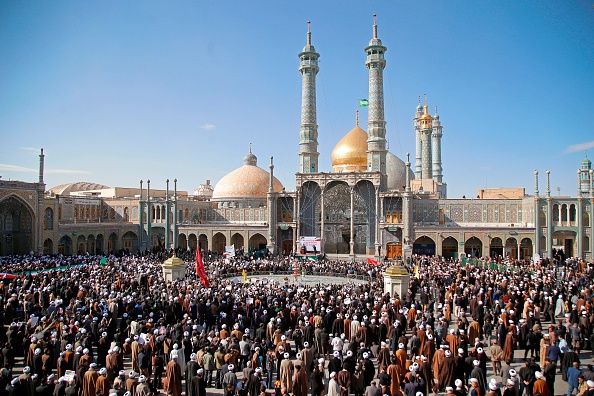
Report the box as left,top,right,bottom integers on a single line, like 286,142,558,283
299,21,320,173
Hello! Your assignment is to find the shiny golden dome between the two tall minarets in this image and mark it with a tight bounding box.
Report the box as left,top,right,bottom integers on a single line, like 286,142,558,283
331,124,367,172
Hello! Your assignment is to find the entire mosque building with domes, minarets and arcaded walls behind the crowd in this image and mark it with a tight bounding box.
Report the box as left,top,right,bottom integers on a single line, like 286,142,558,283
0,19,594,260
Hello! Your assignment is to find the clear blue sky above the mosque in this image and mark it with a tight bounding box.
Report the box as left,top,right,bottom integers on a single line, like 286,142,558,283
0,0,594,198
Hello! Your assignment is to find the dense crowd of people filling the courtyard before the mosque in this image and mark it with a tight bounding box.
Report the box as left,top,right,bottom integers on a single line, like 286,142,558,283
0,252,594,396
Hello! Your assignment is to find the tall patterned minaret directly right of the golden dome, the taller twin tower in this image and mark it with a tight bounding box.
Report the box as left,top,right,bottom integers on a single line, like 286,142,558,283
365,14,388,175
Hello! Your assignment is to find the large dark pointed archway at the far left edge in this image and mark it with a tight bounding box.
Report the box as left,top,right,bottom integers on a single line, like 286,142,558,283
0,196,33,255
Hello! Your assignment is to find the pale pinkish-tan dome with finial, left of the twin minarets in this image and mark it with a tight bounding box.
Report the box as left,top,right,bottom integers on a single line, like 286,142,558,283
212,148,283,201
